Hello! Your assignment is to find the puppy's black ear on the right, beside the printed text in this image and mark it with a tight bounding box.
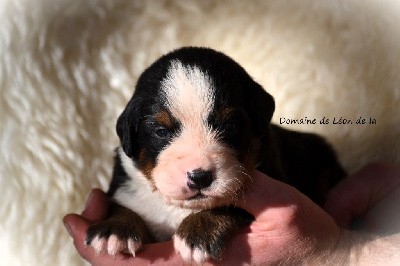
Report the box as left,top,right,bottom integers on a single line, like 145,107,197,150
248,83,275,136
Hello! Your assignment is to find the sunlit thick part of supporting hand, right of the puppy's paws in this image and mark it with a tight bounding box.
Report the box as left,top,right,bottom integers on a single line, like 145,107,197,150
217,171,341,265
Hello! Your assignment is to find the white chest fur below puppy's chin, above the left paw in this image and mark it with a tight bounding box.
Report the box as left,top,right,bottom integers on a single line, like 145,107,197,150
114,148,196,241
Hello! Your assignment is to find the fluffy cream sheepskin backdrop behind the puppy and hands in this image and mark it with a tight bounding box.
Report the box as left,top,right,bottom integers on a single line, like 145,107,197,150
0,0,400,265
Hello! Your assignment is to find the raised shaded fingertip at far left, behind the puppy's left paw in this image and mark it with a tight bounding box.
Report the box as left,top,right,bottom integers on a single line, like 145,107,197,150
82,188,109,222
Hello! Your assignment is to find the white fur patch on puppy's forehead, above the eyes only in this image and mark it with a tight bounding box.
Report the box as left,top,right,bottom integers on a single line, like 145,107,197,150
162,60,214,123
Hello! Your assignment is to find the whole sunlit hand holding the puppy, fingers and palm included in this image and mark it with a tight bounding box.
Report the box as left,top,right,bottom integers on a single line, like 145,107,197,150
64,171,340,265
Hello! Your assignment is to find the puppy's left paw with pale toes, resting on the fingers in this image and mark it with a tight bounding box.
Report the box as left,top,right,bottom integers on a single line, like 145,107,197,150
85,220,143,257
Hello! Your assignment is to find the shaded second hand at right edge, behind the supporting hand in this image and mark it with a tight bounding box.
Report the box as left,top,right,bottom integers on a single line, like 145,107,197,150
325,163,400,234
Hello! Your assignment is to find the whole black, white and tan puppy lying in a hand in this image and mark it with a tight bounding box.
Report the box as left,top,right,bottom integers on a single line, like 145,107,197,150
86,47,345,263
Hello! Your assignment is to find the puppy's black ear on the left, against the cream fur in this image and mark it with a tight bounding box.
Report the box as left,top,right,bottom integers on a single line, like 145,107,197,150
117,98,140,158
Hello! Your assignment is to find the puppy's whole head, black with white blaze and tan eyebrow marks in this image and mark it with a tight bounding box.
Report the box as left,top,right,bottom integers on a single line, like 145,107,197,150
117,48,274,208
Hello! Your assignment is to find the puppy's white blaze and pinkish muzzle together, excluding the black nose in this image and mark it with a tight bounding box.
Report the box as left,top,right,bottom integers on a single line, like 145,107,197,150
151,60,248,208
